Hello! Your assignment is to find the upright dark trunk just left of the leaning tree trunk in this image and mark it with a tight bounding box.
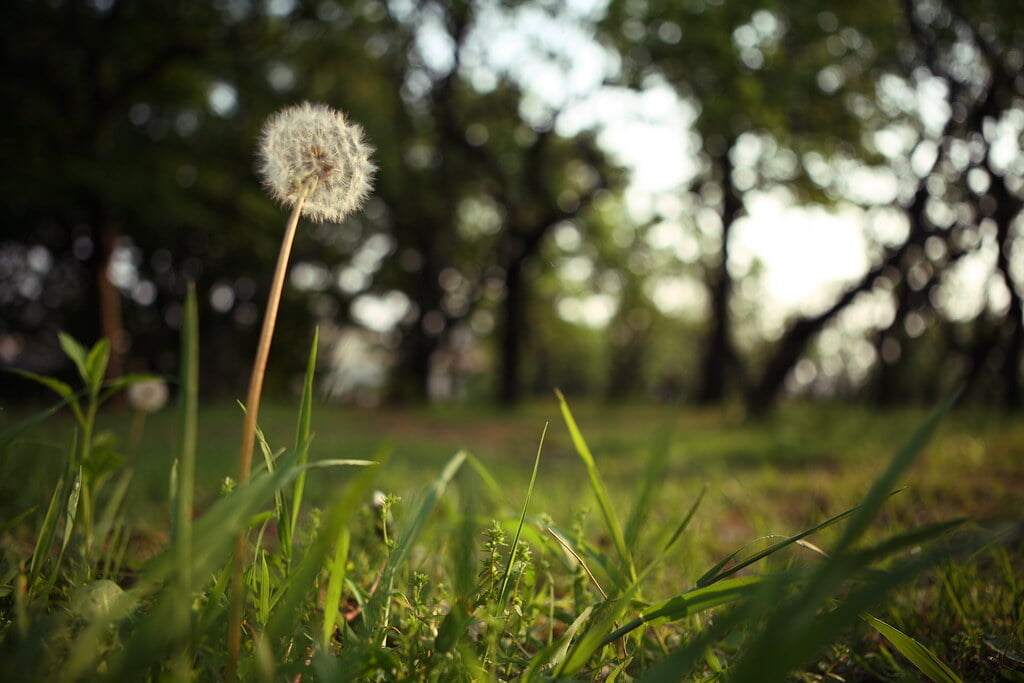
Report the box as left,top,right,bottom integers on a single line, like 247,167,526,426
697,149,743,404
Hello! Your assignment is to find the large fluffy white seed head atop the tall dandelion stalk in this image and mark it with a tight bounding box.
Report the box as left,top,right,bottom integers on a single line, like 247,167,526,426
259,102,376,222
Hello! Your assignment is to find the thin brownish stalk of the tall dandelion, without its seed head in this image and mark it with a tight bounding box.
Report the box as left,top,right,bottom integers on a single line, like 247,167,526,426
225,177,316,681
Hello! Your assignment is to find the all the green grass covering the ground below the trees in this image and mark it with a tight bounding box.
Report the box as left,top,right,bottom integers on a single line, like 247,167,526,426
0,349,1024,681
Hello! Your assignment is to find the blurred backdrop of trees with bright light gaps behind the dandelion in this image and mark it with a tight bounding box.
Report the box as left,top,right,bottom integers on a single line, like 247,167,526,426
0,0,1024,413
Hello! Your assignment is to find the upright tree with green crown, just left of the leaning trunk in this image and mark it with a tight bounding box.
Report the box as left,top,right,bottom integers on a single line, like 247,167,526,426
601,2,901,402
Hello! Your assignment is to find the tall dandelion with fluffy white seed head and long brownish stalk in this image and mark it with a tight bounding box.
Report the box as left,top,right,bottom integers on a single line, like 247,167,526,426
225,102,375,681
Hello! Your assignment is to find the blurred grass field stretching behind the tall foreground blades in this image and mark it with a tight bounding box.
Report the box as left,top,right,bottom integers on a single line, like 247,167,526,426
0,396,1024,680
